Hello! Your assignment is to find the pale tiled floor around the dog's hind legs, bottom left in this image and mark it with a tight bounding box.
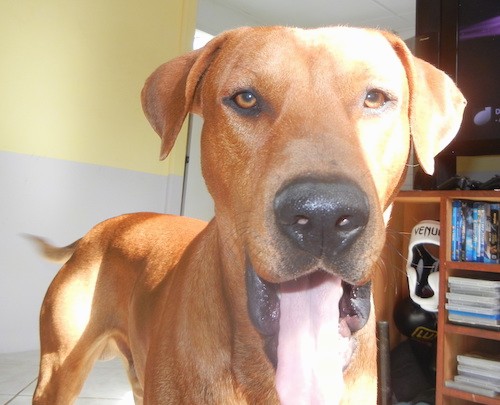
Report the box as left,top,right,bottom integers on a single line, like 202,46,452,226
0,351,134,405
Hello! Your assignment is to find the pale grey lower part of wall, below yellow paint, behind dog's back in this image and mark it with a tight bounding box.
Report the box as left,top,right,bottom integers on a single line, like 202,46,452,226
0,151,182,352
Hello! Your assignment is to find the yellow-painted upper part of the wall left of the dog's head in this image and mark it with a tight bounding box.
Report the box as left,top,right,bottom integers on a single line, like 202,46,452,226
0,0,196,174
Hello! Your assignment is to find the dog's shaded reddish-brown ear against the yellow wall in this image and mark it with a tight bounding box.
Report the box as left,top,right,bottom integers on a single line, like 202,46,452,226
141,34,227,160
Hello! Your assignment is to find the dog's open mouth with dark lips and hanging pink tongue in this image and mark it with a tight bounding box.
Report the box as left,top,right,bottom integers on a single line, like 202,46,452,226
246,265,371,403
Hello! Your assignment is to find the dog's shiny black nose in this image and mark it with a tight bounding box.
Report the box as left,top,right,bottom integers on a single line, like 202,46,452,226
274,179,369,258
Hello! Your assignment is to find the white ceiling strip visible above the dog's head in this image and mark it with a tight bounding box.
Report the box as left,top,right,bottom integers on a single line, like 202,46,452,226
212,0,416,39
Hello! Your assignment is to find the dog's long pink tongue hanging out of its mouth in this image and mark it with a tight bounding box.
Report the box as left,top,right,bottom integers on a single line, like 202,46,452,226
276,273,350,405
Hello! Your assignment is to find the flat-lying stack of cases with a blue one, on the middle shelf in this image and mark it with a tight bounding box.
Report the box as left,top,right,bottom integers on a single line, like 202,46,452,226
446,276,500,330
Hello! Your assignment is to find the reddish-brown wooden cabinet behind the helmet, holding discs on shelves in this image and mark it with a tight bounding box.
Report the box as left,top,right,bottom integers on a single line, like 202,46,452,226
374,191,500,405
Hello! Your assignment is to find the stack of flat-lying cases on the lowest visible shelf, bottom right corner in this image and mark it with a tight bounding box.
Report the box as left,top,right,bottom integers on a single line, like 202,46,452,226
445,353,500,398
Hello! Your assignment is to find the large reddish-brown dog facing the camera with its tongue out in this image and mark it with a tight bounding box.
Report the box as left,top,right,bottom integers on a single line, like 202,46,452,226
34,28,465,405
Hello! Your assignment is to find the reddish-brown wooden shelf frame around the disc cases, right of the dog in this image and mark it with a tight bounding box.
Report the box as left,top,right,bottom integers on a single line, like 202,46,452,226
388,191,500,405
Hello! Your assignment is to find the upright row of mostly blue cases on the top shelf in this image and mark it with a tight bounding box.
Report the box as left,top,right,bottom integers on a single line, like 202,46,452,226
451,200,500,263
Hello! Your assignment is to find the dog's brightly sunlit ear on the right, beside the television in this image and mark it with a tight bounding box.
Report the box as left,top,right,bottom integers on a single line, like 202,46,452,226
384,32,466,174
